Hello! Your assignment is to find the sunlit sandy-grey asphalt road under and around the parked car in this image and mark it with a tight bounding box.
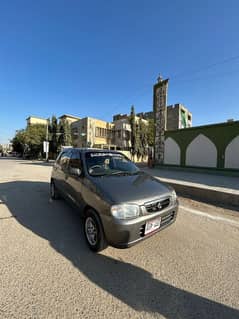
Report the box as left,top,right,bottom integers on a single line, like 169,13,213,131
0,158,239,319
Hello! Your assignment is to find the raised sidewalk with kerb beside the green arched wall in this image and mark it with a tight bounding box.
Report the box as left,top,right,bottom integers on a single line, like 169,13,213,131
142,167,239,210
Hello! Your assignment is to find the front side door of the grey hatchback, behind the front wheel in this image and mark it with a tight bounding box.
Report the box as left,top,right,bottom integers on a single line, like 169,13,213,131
67,150,84,209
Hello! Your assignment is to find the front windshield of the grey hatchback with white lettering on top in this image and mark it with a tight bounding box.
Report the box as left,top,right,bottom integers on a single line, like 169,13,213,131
86,152,140,176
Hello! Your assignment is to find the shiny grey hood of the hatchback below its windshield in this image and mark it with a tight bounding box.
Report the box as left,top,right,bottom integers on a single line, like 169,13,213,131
92,172,172,205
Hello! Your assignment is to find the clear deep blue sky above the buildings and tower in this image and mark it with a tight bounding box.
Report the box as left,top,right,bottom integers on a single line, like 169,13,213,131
0,0,239,143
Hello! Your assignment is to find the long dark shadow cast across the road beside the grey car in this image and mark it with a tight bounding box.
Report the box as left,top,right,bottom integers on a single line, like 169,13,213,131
0,181,239,319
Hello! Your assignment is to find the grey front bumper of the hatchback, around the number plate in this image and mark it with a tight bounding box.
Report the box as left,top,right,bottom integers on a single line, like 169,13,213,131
102,203,178,248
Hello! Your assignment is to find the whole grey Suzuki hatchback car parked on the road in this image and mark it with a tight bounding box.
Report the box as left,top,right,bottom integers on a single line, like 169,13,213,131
50,148,178,251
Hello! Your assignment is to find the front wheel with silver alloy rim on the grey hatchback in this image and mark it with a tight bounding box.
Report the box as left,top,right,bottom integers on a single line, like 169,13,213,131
84,209,107,252
